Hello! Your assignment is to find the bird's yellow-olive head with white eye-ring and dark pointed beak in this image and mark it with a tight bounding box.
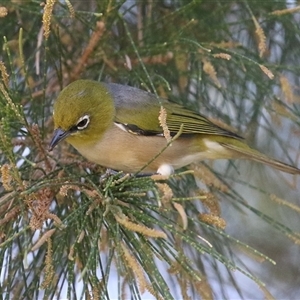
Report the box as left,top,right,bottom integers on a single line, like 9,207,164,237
50,80,115,150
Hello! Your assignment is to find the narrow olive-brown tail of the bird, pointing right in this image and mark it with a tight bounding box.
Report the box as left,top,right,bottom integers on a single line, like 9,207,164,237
221,143,300,174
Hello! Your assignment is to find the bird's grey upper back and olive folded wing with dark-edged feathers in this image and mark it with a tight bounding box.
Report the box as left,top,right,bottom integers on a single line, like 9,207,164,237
106,83,242,139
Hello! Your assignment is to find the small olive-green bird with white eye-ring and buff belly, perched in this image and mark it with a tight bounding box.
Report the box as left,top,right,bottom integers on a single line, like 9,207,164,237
49,80,300,175
